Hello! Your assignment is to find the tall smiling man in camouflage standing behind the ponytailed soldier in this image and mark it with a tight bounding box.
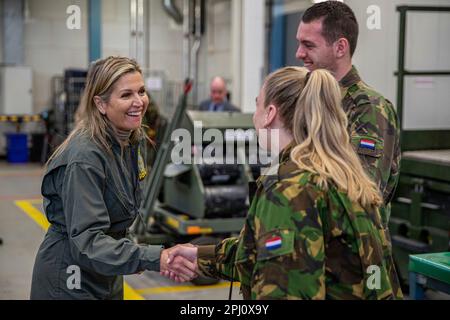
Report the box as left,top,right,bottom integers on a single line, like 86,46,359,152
296,1,401,227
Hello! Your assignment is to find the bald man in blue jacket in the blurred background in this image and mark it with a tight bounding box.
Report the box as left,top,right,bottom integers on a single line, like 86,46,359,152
199,77,240,112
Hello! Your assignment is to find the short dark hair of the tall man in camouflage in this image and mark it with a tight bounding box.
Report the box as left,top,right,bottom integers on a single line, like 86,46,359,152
302,1,359,57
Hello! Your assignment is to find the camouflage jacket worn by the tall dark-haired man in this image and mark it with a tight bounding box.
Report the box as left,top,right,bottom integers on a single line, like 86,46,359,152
340,67,401,226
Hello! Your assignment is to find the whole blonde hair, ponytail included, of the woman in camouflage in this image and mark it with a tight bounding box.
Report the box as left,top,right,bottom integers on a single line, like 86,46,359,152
265,67,383,207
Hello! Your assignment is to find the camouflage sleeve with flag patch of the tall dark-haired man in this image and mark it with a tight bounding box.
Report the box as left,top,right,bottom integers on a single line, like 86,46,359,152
349,97,401,215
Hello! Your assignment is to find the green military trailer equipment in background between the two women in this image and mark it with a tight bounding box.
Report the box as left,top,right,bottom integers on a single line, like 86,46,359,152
132,85,269,284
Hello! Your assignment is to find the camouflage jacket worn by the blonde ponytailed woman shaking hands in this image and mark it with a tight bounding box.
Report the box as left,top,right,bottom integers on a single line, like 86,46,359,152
198,146,402,299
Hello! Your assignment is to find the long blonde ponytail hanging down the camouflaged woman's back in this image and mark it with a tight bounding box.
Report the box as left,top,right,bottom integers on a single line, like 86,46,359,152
291,70,382,207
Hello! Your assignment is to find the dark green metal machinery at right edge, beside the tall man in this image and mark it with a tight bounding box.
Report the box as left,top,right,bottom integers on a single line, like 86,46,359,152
390,131,450,283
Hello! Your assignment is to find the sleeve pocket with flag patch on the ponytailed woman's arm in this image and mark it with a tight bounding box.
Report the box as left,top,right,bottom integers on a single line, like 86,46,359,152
256,229,295,261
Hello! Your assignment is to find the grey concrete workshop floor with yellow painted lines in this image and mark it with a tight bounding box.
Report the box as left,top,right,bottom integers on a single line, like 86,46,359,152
0,161,450,300
